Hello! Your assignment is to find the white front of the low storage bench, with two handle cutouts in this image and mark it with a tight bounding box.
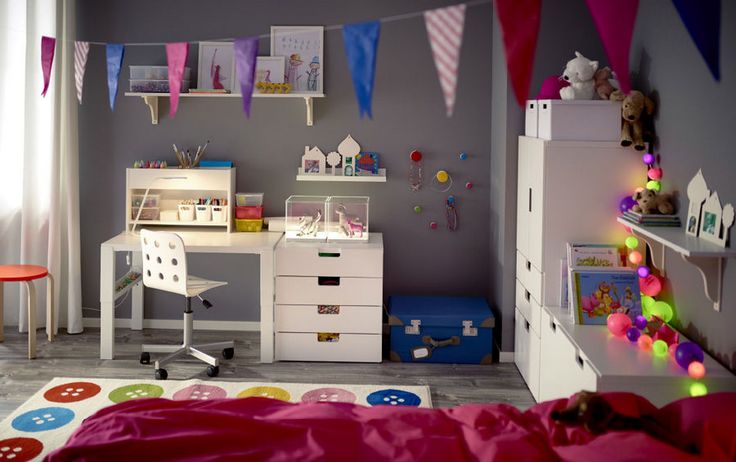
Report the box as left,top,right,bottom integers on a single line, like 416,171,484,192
539,311,598,401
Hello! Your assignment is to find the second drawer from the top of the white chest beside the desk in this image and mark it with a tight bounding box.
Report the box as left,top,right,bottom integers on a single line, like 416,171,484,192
276,275,383,306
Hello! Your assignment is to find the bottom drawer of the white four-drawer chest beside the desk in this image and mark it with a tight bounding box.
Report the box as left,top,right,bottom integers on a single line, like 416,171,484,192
275,332,381,363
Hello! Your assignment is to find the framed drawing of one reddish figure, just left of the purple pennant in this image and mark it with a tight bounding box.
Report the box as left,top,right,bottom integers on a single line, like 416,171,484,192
197,42,237,93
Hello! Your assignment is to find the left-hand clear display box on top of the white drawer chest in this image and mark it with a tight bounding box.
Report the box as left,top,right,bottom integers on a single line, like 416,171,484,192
284,196,327,241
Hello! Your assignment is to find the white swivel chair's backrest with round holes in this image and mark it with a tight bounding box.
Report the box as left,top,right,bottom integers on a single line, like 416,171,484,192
141,229,187,296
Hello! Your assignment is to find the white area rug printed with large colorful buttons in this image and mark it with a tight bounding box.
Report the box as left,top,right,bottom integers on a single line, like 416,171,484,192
0,377,432,462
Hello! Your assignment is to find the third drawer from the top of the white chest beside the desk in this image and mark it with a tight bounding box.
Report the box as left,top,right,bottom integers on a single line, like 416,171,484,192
275,305,382,334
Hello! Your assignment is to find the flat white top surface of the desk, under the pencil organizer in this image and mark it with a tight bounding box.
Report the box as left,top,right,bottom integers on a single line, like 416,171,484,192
101,228,283,254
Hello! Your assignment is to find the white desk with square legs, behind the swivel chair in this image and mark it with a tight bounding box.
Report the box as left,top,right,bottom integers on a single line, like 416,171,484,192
100,229,283,363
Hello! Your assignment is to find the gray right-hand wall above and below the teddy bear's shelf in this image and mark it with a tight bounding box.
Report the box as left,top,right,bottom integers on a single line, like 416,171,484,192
631,2,736,370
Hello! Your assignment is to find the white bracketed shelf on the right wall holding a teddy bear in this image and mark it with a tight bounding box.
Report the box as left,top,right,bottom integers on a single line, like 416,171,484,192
618,217,736,311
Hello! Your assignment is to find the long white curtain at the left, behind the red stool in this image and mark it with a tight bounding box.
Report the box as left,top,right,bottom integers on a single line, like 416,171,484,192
0,0,83,334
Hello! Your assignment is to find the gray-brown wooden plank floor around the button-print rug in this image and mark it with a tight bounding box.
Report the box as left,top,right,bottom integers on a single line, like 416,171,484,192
0,327,534,420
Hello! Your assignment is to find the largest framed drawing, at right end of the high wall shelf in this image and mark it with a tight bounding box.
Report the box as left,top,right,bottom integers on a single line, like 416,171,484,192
271,26,324,93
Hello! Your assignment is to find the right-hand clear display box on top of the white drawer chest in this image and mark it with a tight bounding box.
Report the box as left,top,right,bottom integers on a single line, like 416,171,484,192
325,196,370,242
